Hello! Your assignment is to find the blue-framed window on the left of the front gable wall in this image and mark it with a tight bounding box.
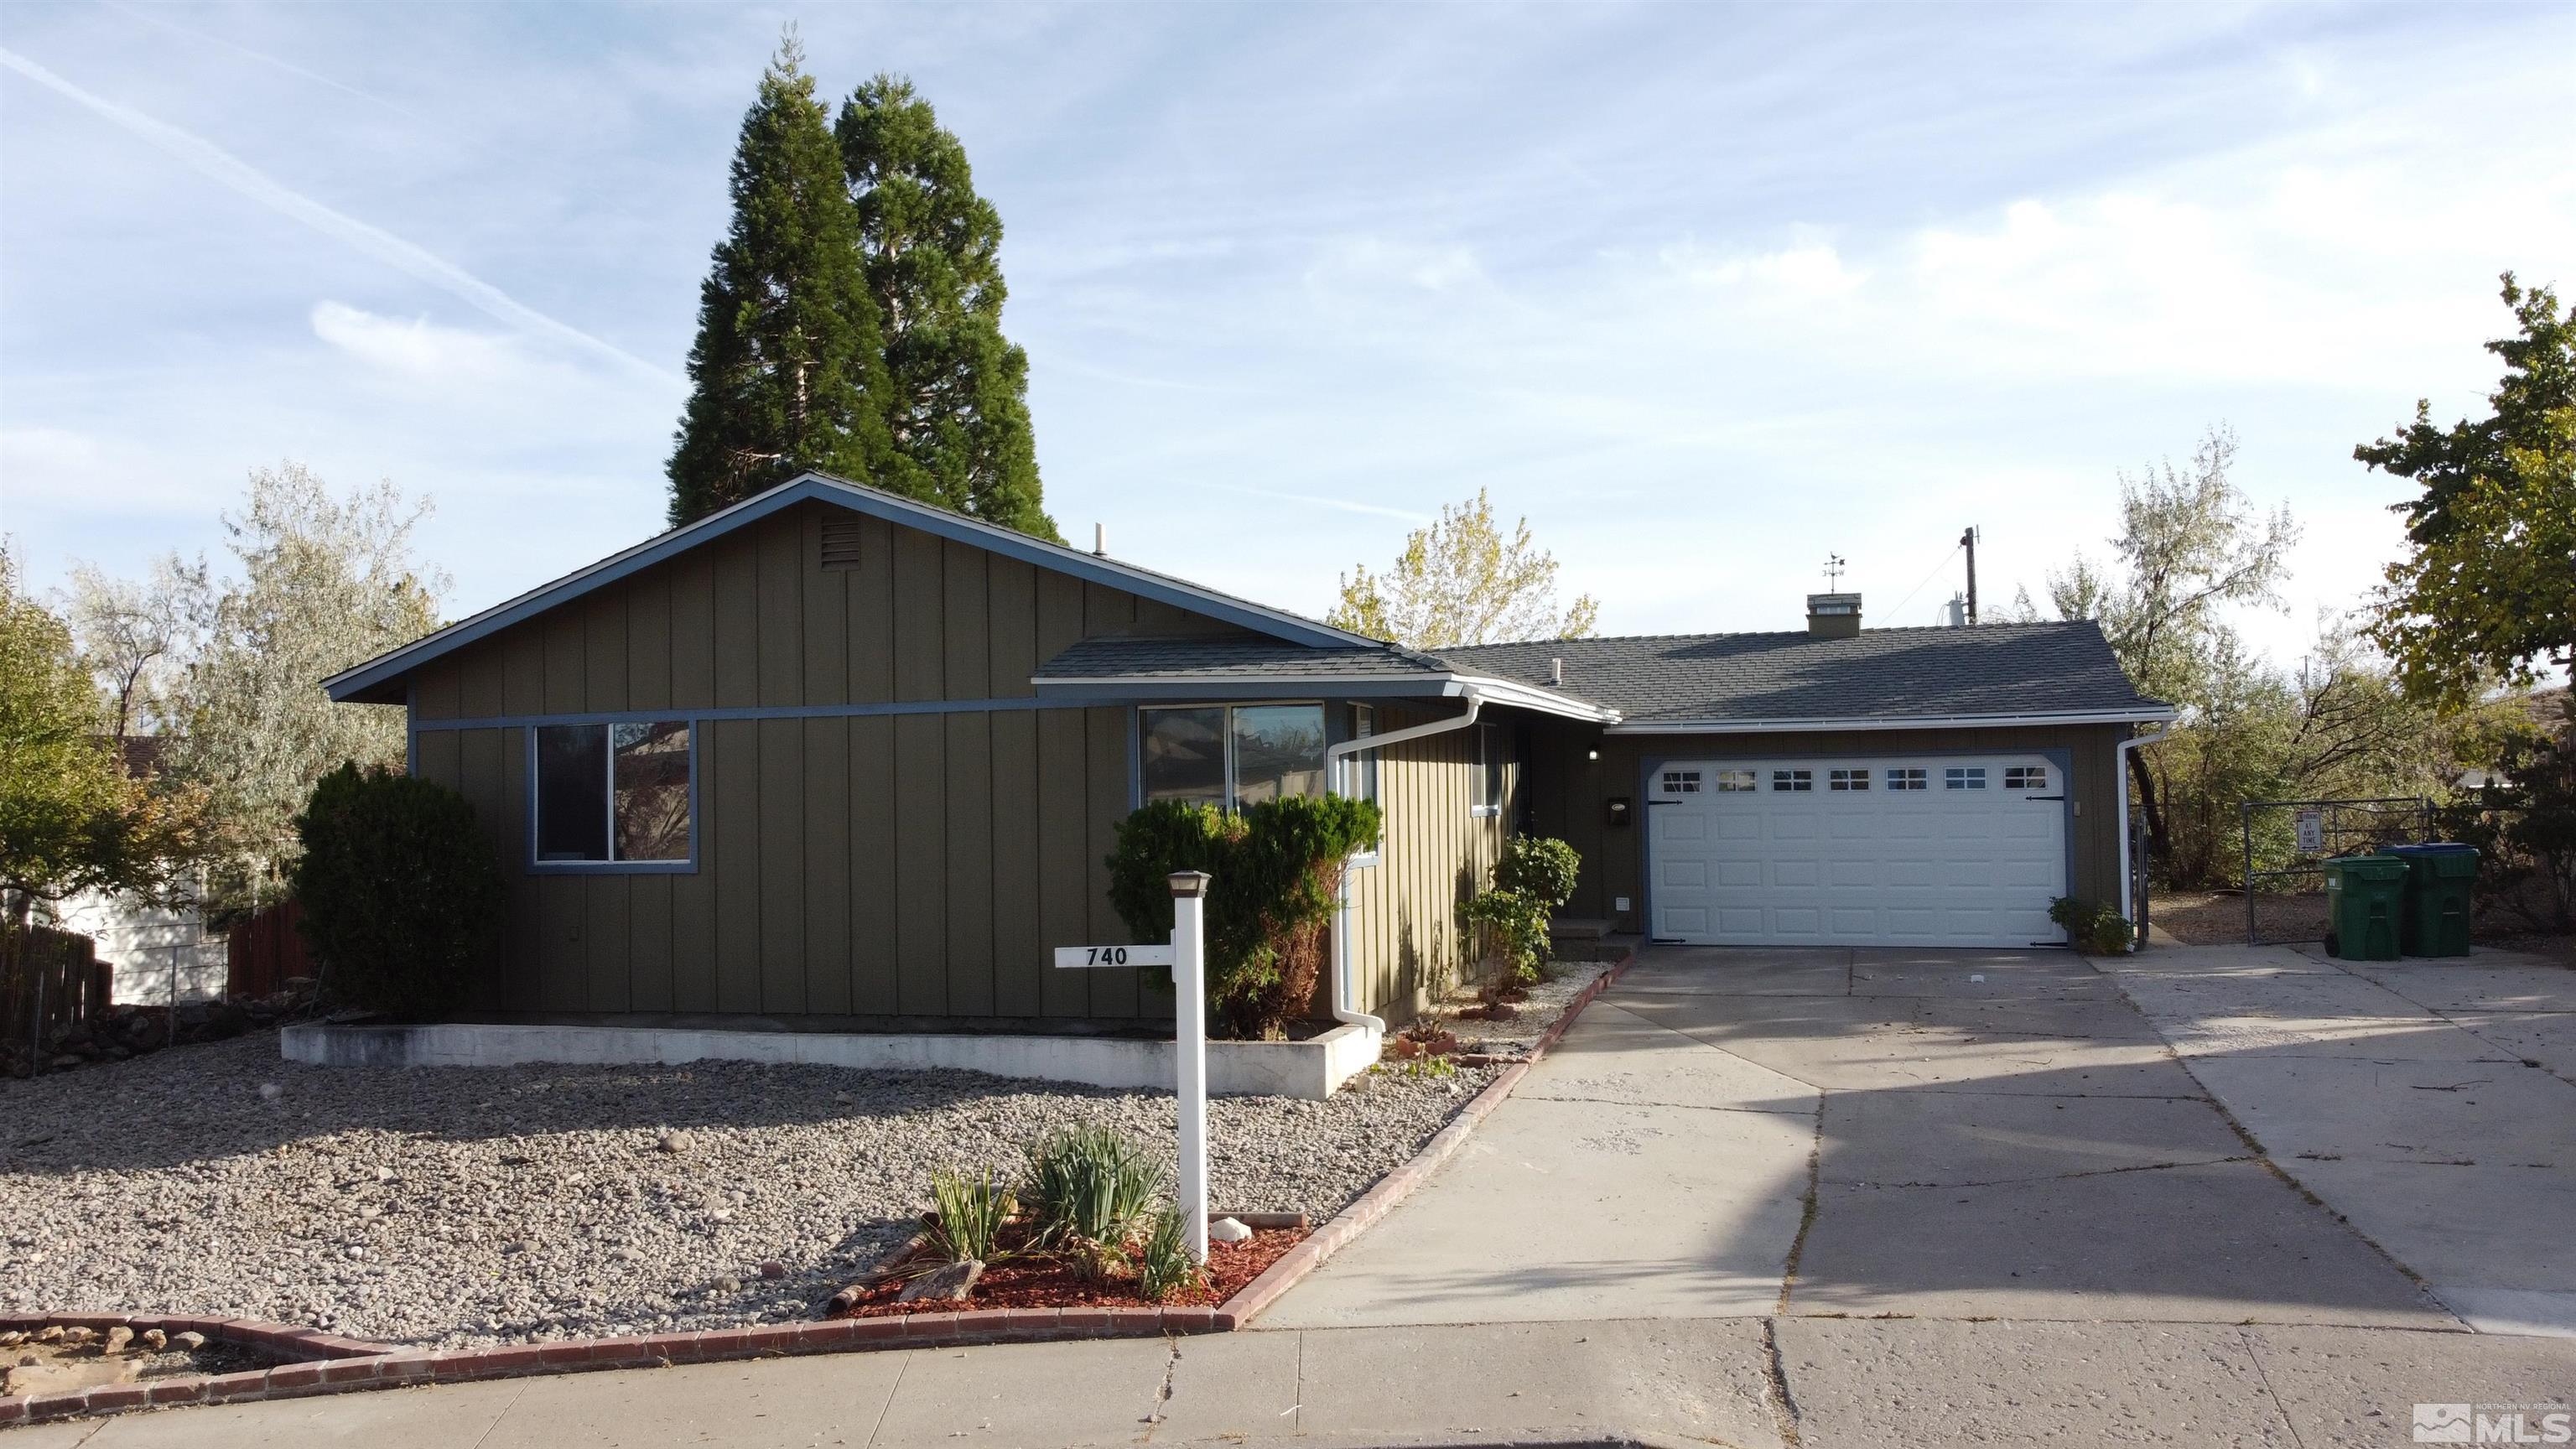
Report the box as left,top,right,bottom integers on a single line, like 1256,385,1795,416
533,719,695,869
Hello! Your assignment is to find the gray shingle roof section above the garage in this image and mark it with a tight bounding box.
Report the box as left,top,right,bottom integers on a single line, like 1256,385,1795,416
1440,621,2156,724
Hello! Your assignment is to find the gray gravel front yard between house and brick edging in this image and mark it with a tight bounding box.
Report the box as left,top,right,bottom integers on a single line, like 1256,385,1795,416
0,1031,1492,1346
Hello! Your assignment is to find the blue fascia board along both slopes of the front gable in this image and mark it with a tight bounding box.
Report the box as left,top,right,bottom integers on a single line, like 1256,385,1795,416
322,472,1379,704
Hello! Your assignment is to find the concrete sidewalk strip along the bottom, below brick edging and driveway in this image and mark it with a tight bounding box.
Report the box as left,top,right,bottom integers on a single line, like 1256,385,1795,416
0,1317,2576,1449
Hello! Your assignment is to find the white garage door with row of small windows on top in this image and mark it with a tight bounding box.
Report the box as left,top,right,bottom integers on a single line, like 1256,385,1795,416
1646,756,2066,946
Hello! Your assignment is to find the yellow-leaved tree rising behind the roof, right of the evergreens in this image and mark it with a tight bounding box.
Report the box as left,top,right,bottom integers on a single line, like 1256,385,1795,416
1327,487,1600,650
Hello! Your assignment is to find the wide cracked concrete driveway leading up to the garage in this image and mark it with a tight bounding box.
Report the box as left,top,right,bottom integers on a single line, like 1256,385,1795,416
1262,949,2576,1333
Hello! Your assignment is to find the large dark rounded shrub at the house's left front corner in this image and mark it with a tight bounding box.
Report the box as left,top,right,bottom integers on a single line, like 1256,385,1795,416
291,766,502,1019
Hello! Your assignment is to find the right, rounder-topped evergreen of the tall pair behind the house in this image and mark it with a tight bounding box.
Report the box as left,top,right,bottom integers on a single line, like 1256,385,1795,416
837,75,1059,539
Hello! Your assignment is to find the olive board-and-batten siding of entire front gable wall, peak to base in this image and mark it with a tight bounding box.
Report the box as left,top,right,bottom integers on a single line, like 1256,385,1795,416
409,506,1185,1019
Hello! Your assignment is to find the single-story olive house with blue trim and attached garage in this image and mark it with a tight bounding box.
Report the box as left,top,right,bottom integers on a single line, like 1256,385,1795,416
327,475,2172,1034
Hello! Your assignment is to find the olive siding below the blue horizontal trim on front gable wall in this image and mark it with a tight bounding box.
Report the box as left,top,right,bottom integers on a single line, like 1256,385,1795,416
415,706,1138,1019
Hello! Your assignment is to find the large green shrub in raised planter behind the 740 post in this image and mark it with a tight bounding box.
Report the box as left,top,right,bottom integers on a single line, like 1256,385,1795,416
1108,794,1379,1039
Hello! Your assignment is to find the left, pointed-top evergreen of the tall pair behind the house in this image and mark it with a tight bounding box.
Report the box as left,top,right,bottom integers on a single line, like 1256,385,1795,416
670,29,915,526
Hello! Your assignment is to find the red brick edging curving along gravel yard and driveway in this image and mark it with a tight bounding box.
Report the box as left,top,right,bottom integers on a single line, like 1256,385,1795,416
0,952,1636,1428
